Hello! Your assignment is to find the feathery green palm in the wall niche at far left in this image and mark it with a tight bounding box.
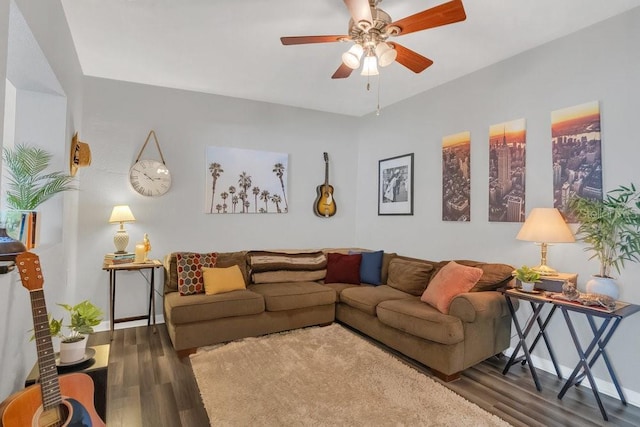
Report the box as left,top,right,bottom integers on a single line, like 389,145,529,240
2,144,75,249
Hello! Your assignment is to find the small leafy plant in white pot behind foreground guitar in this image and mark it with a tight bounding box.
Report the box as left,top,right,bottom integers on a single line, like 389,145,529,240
49,300,102,363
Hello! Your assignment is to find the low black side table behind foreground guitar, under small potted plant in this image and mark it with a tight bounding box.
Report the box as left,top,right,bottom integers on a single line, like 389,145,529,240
24,344,109,421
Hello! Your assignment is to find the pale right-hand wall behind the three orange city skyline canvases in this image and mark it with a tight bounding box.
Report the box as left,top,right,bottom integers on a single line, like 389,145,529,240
356,9,640,404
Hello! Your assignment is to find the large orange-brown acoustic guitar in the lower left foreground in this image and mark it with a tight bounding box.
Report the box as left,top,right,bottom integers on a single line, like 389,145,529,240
0,252,105,427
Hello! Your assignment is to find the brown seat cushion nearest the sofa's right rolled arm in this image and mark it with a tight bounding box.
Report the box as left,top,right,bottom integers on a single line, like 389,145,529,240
376,298,464,345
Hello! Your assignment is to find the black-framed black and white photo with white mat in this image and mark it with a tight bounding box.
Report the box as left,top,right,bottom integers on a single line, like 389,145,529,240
378,153,413,215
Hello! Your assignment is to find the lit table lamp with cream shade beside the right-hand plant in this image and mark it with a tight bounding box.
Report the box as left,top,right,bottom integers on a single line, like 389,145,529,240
516,208,576,276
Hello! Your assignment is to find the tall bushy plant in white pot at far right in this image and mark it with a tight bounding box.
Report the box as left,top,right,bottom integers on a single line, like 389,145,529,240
569,183,640,299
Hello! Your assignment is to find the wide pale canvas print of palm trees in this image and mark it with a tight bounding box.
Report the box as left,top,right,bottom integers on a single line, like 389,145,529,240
205,146,289,214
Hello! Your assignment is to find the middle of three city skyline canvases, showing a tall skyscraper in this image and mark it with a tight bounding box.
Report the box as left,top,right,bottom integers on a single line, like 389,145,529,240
489,119,526,222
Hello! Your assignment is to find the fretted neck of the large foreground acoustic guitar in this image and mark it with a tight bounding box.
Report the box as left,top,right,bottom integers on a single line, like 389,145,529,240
29,289,62,410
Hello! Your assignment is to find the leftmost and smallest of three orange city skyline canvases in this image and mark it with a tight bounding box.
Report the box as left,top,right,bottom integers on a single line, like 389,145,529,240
442,131,471,222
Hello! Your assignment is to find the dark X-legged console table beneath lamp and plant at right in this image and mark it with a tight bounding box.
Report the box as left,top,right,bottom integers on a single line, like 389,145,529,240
502,289,640,421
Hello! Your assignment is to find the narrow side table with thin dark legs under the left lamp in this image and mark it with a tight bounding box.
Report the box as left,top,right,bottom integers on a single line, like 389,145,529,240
102,259,162,339
